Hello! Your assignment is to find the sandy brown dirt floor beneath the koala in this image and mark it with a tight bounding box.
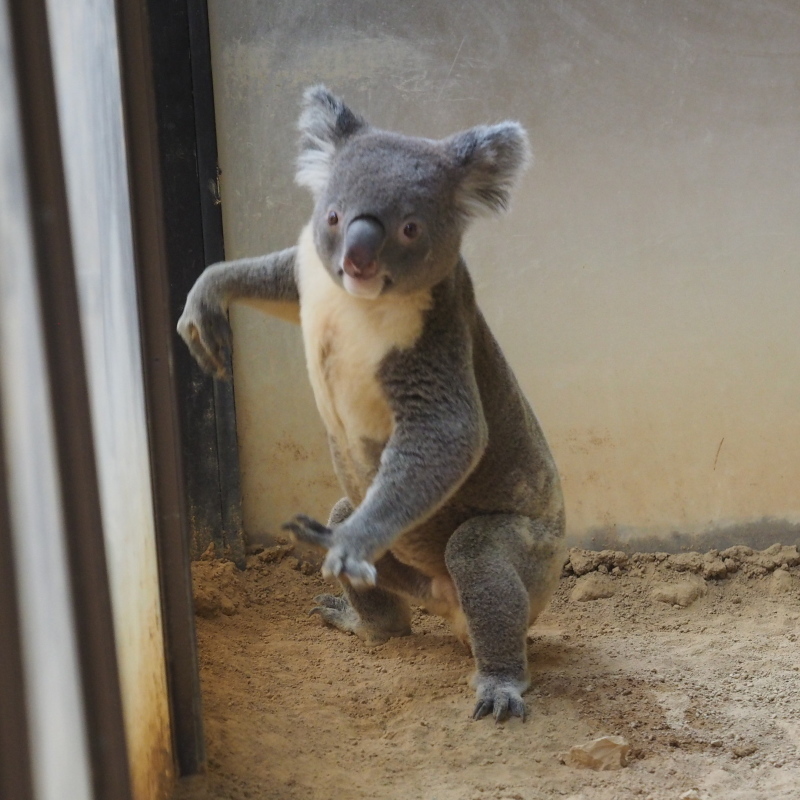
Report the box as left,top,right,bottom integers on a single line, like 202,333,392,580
176,545,800,800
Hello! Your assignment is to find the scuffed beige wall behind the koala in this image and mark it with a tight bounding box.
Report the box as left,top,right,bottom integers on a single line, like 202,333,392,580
210,0,800,547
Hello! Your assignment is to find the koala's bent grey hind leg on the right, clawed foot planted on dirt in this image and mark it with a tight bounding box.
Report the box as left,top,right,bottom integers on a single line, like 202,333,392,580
445,514,564,721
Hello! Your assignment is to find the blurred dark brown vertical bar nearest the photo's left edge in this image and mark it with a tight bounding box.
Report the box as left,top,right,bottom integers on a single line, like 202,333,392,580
9,0,131,800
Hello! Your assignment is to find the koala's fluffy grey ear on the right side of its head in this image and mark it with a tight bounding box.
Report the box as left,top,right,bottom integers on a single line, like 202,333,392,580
445,122,531,217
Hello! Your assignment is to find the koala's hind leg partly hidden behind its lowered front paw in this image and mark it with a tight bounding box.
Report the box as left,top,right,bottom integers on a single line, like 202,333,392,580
310,497,411,646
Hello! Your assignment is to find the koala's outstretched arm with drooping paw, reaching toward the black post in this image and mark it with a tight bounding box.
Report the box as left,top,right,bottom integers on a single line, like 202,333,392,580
178,247,299,380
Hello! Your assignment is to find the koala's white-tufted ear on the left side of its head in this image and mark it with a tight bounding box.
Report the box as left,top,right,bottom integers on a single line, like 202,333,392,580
295,86,368,194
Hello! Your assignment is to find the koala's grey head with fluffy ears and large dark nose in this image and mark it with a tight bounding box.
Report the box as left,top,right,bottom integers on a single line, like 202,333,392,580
296,86,530,298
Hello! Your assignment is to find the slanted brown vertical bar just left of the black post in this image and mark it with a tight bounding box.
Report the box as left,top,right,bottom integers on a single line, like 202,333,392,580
117,0,205,775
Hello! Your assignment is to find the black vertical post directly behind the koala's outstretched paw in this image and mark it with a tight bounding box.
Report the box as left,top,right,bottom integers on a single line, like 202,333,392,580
148,0,244,567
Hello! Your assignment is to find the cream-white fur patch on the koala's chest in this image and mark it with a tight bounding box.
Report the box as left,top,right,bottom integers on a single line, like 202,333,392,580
297,225,431,478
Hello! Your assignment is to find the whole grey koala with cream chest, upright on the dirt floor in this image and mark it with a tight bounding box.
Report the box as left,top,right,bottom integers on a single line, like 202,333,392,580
178,86,564,721
